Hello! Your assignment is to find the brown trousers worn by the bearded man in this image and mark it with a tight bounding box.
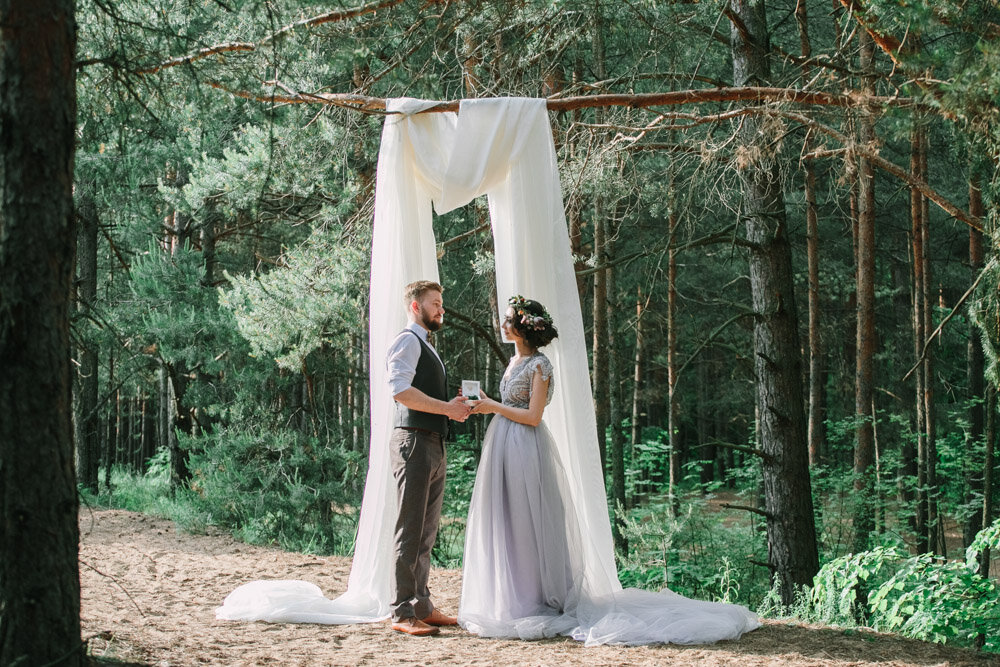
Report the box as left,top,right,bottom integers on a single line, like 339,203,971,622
389,428,447,620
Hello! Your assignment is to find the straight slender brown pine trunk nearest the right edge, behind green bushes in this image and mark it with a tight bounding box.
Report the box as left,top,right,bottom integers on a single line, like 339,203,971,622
962,176,986,547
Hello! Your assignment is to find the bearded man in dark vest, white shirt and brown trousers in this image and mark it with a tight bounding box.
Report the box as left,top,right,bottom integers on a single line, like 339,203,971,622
386,280,470,636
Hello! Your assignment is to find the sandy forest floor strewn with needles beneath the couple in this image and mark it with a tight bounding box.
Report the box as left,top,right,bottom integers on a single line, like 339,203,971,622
80,510,1000,667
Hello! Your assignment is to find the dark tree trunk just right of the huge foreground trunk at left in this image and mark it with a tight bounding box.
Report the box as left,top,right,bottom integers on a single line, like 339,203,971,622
74,193,101,493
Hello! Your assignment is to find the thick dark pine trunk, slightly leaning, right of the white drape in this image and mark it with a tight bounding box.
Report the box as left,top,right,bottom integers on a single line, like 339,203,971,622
730,0,819,605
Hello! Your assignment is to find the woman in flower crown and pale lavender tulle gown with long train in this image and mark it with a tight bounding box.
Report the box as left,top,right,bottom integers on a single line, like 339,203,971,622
458,296,760,645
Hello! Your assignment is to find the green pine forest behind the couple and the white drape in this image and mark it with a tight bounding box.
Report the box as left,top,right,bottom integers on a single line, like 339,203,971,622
5,0,1000,664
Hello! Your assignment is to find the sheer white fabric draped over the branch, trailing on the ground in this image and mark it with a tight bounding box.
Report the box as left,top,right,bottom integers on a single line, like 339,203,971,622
217,98,756,643
